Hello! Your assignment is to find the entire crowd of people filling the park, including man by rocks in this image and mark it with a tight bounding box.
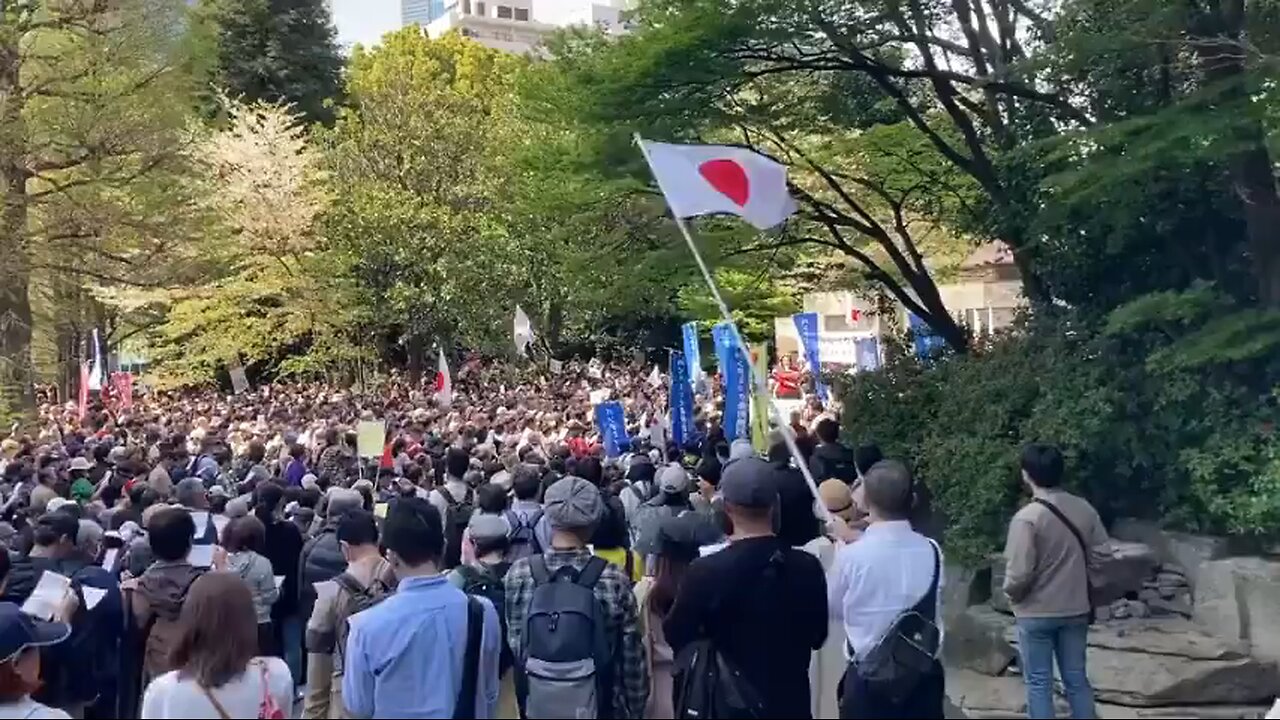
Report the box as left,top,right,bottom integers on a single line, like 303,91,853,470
0,361,1106,719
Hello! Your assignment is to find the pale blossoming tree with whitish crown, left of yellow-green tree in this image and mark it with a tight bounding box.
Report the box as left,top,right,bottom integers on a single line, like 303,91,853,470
111,99,356,384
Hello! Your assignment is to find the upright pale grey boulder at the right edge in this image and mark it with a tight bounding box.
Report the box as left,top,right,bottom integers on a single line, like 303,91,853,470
1193,557,1280,660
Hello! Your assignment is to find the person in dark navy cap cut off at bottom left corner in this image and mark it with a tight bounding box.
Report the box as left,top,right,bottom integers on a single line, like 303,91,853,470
0,602,72,720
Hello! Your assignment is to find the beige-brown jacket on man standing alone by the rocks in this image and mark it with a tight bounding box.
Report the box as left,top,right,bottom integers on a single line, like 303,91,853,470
1004,489,1110,618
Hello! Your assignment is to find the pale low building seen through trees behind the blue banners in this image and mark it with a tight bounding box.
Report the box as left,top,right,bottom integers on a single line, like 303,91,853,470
773,242,1027,365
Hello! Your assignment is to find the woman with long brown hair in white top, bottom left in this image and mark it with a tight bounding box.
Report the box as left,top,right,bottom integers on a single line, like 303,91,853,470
141,573,293,720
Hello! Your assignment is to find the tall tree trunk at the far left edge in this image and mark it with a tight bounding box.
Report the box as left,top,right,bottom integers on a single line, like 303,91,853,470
0,41,36,416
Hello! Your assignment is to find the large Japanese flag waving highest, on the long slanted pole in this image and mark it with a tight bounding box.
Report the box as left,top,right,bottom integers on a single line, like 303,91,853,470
640,140,796,231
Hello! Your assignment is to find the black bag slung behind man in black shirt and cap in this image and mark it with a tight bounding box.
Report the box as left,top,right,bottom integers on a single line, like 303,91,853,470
671,550,786,720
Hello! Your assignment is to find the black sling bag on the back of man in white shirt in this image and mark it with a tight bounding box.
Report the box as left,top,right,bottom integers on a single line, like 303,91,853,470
850,541,942,697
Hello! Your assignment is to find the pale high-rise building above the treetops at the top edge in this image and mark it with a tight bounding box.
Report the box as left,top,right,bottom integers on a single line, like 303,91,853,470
401,0,634,54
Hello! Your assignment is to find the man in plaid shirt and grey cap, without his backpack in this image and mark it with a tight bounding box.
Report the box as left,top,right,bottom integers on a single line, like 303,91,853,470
506,477,649,719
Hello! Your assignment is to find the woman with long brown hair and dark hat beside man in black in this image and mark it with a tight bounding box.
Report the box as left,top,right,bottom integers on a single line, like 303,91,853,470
635,514,704,720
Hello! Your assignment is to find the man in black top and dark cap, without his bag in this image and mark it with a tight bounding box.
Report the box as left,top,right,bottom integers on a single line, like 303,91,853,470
663,457,827,717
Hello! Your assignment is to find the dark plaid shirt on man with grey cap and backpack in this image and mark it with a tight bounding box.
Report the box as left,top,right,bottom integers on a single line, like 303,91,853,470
506,548,649,717
